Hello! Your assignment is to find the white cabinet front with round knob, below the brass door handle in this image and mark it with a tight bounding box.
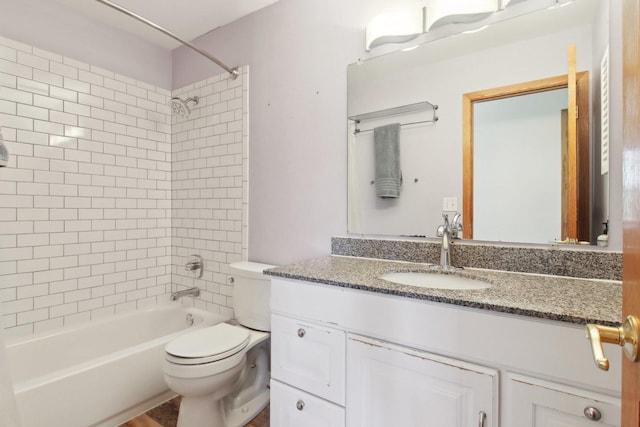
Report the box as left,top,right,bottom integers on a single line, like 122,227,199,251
506,374,620,427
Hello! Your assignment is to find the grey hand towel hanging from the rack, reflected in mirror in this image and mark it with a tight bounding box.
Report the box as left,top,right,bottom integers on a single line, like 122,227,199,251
373,123,402,198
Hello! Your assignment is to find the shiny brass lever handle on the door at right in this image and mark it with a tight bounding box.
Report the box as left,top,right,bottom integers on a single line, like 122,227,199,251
587,316,640,371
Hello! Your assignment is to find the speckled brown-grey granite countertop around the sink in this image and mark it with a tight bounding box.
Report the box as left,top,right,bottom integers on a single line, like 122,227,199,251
265,255,622,326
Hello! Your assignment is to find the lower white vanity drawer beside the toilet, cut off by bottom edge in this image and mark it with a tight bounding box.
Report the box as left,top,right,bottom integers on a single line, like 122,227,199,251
270,380,344,427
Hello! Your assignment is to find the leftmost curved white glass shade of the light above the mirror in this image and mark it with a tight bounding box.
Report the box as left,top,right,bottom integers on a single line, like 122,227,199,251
365,8,425,51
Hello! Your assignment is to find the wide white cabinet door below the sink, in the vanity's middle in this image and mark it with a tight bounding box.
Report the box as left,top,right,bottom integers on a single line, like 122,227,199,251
346,334,498,427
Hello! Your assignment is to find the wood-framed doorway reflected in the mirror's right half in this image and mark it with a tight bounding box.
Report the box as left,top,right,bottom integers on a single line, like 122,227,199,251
462,71,591,243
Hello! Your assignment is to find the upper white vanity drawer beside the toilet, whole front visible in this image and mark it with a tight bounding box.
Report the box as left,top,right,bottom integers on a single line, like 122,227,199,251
271,314,345,405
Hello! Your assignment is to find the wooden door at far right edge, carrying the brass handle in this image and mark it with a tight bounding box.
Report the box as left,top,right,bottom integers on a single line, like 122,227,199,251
622,0,640,427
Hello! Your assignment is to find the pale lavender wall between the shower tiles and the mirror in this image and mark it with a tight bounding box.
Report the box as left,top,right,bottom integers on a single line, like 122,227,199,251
173,0,385,264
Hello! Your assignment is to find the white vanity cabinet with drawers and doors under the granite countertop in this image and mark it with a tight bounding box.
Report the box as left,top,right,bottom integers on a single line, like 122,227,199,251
271,277,621,427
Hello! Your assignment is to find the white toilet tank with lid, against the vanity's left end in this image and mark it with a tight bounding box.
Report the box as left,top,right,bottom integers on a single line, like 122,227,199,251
229,261,275,331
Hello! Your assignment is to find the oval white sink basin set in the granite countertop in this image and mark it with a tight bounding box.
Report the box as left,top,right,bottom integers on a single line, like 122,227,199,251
380,271,491,290
